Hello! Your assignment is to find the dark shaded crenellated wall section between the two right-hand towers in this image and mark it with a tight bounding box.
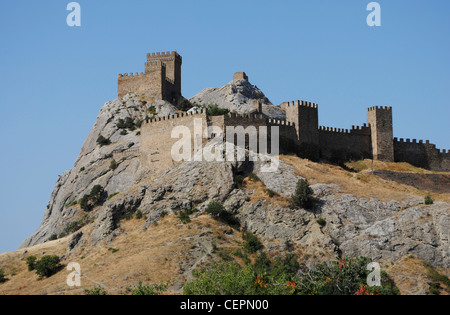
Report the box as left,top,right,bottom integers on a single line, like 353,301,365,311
319,125,372,162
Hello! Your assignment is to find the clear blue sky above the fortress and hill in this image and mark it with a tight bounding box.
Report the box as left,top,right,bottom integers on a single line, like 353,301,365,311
0,0,450,252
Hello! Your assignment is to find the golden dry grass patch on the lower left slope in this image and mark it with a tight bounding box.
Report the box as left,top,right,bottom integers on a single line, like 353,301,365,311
0,216,242,295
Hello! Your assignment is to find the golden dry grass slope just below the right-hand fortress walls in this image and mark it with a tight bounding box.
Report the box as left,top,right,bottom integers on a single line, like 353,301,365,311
280,155,450,202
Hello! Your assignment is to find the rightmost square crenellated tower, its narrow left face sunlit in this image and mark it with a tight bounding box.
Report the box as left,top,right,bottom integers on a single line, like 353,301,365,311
367,106,394,162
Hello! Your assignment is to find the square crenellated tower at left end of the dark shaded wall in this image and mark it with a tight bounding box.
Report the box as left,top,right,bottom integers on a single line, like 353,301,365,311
281,101,319,159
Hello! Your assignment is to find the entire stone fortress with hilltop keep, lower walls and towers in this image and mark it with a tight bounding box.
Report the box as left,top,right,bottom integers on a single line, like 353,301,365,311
118,51,450,171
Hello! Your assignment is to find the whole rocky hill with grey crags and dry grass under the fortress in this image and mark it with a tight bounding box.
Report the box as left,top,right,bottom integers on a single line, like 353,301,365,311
0,80,450,294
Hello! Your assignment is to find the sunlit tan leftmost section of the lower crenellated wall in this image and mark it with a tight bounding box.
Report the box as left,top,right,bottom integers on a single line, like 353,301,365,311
140,112,207,170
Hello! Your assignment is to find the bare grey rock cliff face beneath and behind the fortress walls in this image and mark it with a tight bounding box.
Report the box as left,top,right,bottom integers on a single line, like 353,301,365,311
20,87,450,268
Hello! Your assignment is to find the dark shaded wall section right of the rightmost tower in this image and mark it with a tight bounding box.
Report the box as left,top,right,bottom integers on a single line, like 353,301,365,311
394,138,450,171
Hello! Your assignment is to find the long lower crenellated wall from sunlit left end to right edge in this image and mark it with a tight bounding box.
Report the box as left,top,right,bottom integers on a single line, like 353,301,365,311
140,107,450,171
